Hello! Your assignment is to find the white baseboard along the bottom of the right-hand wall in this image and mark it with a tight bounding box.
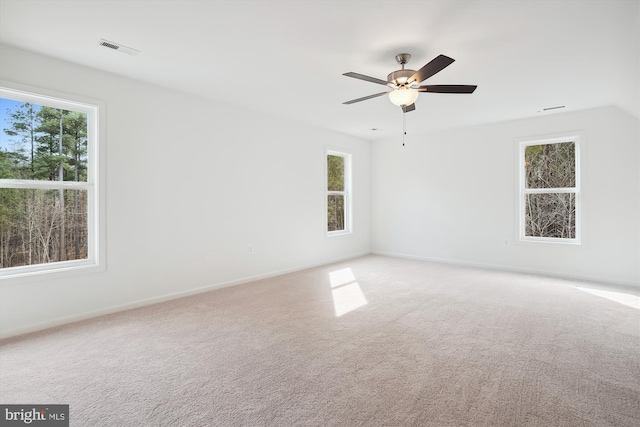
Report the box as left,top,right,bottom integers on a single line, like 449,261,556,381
371,251,640,294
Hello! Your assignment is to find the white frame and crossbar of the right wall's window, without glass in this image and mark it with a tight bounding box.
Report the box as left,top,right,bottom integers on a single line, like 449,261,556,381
518,133,584,245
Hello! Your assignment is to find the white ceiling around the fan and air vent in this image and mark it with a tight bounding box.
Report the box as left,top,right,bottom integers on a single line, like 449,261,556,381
0,0,640,140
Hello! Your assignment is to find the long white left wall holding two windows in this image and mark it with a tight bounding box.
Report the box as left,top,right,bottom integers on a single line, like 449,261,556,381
0,45,370,336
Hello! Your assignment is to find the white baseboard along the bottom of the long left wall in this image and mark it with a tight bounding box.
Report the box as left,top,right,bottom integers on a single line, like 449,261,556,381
0,251,371,339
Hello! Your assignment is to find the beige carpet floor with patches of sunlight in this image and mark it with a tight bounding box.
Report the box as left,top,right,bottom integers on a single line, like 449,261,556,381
0,255,640,427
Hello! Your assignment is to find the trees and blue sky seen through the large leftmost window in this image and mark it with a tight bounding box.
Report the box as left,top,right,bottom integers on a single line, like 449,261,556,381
0,103,88,268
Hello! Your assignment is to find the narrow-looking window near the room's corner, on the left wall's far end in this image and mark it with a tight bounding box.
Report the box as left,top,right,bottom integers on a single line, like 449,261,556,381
327,151,351,234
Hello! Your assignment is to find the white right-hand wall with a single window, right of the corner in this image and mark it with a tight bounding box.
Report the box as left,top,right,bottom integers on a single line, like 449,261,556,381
371,107,640,285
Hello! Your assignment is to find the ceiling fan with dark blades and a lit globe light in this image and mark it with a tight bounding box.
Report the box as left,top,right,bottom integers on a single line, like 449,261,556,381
343,53,477,113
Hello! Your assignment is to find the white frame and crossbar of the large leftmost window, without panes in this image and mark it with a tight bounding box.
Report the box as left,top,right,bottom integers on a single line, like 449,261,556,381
0,81,105,283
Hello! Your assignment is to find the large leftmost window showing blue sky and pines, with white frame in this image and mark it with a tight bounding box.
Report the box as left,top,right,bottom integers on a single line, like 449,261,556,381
0,88,99,277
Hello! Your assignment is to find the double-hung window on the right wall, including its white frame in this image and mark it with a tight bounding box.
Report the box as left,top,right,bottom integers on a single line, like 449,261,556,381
520,136,580,244
